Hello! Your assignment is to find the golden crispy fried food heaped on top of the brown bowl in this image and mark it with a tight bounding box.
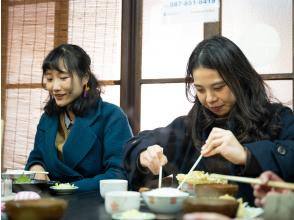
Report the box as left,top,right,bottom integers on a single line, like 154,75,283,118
176,171,228,185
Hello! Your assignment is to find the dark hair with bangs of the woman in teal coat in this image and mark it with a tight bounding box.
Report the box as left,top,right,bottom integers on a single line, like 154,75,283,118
42,44,101,116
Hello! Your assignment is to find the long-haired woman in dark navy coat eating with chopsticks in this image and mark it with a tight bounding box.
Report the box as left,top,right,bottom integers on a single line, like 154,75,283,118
124,36,294,204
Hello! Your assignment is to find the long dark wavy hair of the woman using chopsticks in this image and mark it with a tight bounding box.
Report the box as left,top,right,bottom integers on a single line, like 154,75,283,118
186,36,282,146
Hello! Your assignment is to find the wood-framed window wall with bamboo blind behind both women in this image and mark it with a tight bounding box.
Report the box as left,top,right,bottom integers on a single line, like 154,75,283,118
1,0,294,168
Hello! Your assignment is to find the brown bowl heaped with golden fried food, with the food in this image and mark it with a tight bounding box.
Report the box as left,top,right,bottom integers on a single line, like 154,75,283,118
176,171,238,197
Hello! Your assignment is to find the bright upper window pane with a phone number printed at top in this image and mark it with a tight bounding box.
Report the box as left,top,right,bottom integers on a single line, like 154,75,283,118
142,0,219,79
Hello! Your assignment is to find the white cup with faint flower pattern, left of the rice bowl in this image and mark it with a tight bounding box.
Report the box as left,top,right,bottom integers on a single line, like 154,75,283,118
105,191,140,214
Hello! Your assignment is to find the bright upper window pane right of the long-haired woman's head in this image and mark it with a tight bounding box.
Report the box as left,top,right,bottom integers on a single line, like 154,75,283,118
222,0,293,74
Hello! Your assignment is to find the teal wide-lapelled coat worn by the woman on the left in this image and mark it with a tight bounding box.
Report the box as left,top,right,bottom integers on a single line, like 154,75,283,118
25,100,132,191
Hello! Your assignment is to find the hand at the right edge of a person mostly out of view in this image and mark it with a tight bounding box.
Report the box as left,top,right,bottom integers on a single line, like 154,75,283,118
253,171,291,206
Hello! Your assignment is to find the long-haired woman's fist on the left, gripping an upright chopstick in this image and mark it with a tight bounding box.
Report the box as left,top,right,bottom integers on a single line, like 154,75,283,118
139,145,167,175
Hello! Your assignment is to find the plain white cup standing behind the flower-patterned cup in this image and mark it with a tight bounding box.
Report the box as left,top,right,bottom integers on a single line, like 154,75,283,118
100,179,128,198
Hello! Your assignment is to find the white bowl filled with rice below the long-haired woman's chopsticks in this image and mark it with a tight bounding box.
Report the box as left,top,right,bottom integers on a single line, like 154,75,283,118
142,187,189,213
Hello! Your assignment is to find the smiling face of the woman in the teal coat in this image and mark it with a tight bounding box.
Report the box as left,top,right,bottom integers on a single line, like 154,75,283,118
44,63,87,107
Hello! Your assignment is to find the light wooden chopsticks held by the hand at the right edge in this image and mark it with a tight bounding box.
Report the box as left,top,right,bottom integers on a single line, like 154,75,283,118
211,173,294,190
